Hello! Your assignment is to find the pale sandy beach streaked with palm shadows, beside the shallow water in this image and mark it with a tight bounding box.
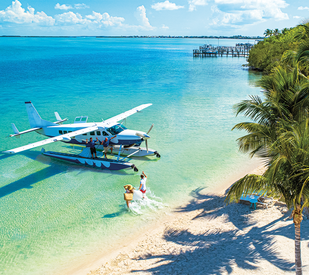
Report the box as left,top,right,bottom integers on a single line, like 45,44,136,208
65,162,309,275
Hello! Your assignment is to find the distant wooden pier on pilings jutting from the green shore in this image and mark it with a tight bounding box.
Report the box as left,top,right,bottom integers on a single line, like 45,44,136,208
193,43,253,57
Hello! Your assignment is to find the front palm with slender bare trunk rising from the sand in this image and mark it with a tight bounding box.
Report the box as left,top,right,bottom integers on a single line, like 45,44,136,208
226,118,309,275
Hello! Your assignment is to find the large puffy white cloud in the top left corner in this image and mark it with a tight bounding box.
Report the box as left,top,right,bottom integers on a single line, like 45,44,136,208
0,0,55,26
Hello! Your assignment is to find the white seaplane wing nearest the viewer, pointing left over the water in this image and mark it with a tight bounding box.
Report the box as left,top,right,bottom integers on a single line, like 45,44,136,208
2,126,98,154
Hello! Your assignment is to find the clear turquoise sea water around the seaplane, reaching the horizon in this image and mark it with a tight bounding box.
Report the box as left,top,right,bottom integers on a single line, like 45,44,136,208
0,38,259,274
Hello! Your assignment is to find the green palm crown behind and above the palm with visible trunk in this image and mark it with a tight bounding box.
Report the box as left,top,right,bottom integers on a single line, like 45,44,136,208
233,66,309,160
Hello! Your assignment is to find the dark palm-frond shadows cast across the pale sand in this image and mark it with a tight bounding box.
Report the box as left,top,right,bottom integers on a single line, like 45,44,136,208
132,189,294,274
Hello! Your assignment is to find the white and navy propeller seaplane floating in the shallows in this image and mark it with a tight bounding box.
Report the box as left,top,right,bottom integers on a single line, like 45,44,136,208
3,101,160,171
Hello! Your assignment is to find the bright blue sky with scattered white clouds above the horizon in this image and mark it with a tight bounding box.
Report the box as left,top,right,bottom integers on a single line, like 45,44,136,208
0,0,309,36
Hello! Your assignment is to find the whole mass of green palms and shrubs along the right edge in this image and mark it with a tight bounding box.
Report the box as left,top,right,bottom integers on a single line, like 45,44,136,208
226,23,309,275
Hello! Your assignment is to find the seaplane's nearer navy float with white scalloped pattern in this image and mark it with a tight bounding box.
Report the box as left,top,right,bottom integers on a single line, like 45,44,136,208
41,147,138,172
